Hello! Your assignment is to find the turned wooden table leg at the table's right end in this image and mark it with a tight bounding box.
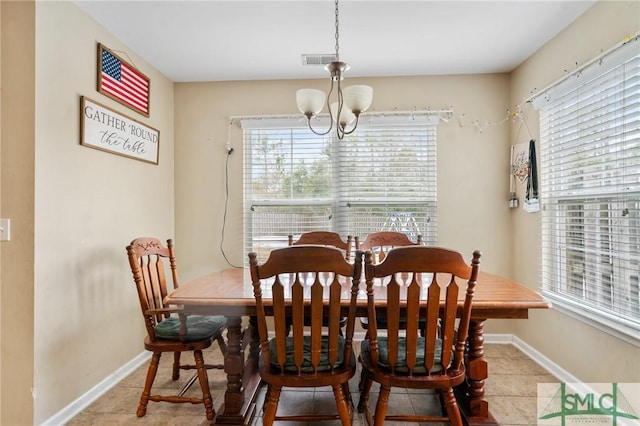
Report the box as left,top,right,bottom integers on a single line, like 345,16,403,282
457,319,498,425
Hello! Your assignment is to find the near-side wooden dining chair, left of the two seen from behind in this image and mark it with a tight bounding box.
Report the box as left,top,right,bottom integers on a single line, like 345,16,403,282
249,245,362,426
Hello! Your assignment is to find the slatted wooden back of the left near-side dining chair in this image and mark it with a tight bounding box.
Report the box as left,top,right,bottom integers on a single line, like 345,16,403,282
249,245,362,374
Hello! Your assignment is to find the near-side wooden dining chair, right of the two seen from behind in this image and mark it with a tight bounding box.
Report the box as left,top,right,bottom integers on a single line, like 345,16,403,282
358,246,481,426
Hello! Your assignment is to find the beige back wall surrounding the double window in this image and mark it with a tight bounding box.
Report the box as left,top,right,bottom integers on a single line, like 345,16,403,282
175,74,511,279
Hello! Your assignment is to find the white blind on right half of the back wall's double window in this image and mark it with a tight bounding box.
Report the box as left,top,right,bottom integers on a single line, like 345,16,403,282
336,125,437,244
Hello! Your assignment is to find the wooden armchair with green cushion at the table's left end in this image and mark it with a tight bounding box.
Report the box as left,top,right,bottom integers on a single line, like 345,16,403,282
127,237,226,420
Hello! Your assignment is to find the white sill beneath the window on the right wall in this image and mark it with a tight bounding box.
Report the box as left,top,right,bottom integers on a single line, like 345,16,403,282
542,290,640,347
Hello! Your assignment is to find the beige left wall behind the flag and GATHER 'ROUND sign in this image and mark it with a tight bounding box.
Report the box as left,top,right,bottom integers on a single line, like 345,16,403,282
31,2,174,424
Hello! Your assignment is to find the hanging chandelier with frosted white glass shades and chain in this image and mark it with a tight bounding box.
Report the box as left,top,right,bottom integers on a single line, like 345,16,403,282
296,0,373,140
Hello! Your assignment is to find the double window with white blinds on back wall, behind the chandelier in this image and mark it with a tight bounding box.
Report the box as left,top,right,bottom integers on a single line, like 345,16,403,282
242,115,437,261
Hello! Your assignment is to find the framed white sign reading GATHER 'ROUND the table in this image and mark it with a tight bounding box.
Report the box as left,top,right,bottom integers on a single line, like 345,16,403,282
80,96,160,164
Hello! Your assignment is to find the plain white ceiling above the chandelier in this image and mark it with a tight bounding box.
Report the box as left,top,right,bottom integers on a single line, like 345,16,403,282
73,0,596,82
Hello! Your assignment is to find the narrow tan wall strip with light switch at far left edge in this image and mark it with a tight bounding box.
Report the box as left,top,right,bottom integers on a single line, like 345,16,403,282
0,1,35,425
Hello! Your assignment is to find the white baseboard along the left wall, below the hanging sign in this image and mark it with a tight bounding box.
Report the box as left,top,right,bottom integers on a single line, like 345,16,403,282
41,351,151,426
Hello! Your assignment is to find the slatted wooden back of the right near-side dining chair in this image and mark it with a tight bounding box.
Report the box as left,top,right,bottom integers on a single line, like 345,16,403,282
365,246,481,375
